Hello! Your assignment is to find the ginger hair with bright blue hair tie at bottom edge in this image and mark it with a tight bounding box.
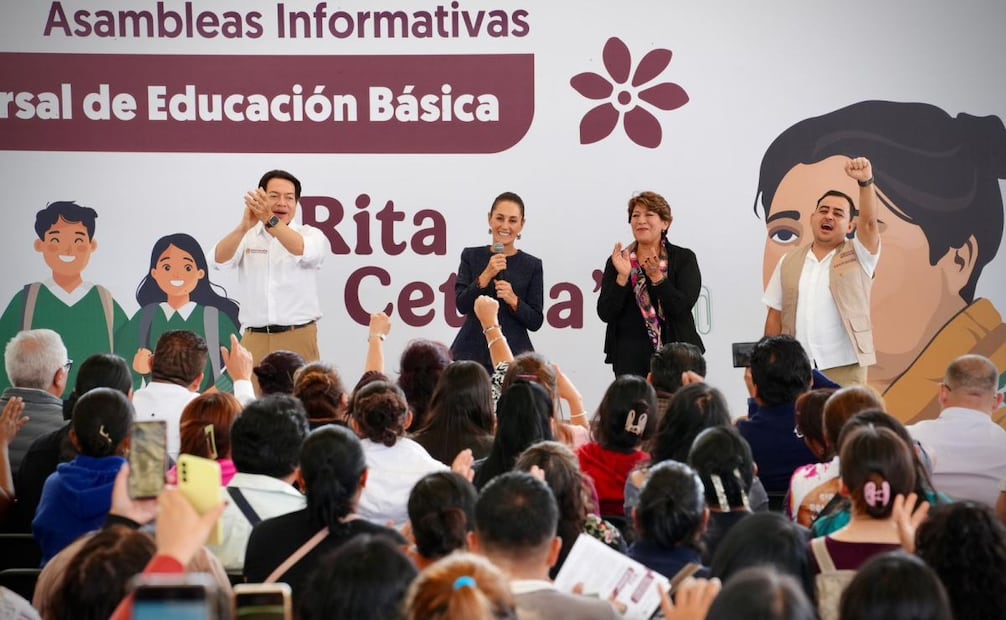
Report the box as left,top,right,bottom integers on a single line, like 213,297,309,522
401,553,517,620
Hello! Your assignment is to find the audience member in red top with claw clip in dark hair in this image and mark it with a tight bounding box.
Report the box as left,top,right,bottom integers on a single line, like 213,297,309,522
576,374,657,517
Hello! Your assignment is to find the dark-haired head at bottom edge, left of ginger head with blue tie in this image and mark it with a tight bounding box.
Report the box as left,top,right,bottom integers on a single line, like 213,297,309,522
297,534,416,620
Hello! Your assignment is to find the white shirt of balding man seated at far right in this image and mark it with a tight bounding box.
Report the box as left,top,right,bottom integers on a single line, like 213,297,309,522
908,407,1006,507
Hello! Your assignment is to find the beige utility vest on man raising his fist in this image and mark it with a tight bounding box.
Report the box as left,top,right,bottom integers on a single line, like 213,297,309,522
780,240,877,366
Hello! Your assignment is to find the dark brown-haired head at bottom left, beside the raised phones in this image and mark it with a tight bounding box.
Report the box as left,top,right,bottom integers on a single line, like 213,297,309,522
47,525,156,620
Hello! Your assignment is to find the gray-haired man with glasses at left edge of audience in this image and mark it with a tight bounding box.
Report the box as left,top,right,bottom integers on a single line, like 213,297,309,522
0,329,73,473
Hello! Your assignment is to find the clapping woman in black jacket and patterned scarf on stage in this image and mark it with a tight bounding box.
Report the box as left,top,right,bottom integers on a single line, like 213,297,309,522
598,191,705,376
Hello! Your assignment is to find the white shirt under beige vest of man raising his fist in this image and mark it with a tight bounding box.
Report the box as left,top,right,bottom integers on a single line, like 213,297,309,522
762,233,880,368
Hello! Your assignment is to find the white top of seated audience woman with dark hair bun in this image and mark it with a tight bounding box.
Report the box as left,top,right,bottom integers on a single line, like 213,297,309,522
356,437,449,528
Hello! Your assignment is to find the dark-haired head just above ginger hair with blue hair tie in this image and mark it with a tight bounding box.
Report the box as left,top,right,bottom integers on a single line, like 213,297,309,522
408,471,478,560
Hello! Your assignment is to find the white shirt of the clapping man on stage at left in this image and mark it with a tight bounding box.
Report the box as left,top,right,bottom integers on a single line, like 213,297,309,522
213,222,328,327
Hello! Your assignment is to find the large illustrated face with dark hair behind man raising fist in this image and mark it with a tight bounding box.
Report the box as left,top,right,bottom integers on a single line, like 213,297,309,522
755,101,1006,424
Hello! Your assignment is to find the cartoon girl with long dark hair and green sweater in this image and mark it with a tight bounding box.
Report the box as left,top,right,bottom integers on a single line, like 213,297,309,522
116,233,240,392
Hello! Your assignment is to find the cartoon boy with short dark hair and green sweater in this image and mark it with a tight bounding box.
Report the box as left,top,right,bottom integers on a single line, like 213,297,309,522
0,201,128,390
